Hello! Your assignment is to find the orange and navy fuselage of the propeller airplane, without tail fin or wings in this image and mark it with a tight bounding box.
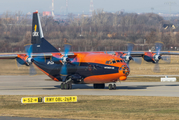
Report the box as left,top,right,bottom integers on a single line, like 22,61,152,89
34,52,130,84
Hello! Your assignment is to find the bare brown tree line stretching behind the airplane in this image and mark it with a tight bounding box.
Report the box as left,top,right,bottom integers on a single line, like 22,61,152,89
0,10,179,52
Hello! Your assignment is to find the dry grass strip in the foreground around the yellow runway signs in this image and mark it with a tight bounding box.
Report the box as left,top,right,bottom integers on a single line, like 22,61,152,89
0,96,179,120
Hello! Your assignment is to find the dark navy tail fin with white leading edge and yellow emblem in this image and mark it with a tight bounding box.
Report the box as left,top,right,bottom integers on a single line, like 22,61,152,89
31,12,59,53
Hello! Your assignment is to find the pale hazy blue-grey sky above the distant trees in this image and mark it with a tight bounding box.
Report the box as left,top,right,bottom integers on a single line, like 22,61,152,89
0,0,179,13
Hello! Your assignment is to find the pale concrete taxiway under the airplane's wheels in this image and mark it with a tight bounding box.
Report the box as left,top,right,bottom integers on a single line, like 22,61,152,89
0,75,179,97
